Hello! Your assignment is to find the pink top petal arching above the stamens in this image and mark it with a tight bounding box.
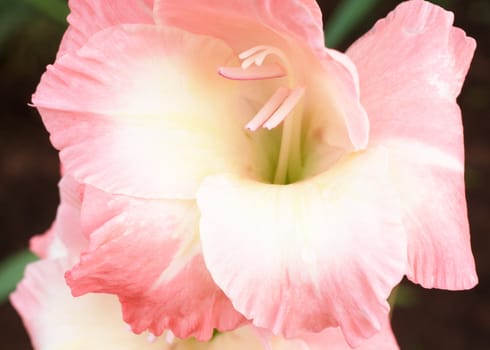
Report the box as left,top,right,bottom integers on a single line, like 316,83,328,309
155,0,324,52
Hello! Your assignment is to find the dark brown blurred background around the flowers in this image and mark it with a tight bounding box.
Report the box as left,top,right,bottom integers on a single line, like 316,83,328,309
0,0,490,350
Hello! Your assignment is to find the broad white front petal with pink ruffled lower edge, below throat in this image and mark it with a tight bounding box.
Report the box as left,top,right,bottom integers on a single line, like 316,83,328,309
197,146,406,345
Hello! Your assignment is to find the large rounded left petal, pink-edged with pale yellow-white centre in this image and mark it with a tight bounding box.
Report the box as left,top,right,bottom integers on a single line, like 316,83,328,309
33,25,254,198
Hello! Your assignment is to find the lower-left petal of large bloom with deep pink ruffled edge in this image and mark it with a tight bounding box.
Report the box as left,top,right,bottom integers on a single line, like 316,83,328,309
66,188,243,340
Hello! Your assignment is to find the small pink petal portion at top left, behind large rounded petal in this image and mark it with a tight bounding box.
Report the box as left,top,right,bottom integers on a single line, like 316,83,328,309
57,0,154,58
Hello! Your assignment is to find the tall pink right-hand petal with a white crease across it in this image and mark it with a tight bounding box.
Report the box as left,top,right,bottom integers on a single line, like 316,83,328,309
347,1,477,289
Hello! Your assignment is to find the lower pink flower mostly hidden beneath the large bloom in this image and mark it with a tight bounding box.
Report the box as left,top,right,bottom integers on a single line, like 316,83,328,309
11,176,397,350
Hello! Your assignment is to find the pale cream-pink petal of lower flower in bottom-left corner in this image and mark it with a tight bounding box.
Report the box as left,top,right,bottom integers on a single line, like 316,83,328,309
10,259,170,350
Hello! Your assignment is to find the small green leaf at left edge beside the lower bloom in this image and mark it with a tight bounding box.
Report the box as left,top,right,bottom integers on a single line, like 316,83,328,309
0,249,38,303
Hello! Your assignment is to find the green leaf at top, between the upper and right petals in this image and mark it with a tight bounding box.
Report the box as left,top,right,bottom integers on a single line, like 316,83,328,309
325,0,380,47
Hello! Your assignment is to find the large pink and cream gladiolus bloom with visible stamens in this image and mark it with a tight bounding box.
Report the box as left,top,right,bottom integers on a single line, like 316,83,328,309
29,0,477,346
